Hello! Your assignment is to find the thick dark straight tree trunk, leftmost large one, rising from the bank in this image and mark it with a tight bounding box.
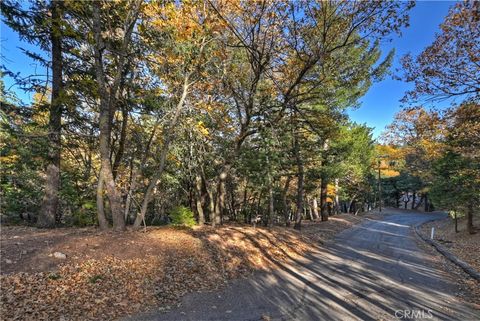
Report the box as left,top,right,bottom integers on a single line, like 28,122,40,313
37,0,63,227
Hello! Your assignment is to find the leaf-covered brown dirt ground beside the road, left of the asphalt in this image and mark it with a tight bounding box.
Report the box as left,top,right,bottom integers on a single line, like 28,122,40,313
0,214,375,321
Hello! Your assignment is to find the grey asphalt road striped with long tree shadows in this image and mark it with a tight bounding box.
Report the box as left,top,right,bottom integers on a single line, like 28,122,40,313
125,213,480,321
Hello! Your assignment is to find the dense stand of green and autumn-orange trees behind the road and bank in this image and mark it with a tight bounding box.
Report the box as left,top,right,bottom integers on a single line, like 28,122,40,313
0,0,480,232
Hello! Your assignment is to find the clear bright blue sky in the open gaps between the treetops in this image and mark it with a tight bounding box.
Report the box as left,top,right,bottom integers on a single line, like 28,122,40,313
1,1,454,137
